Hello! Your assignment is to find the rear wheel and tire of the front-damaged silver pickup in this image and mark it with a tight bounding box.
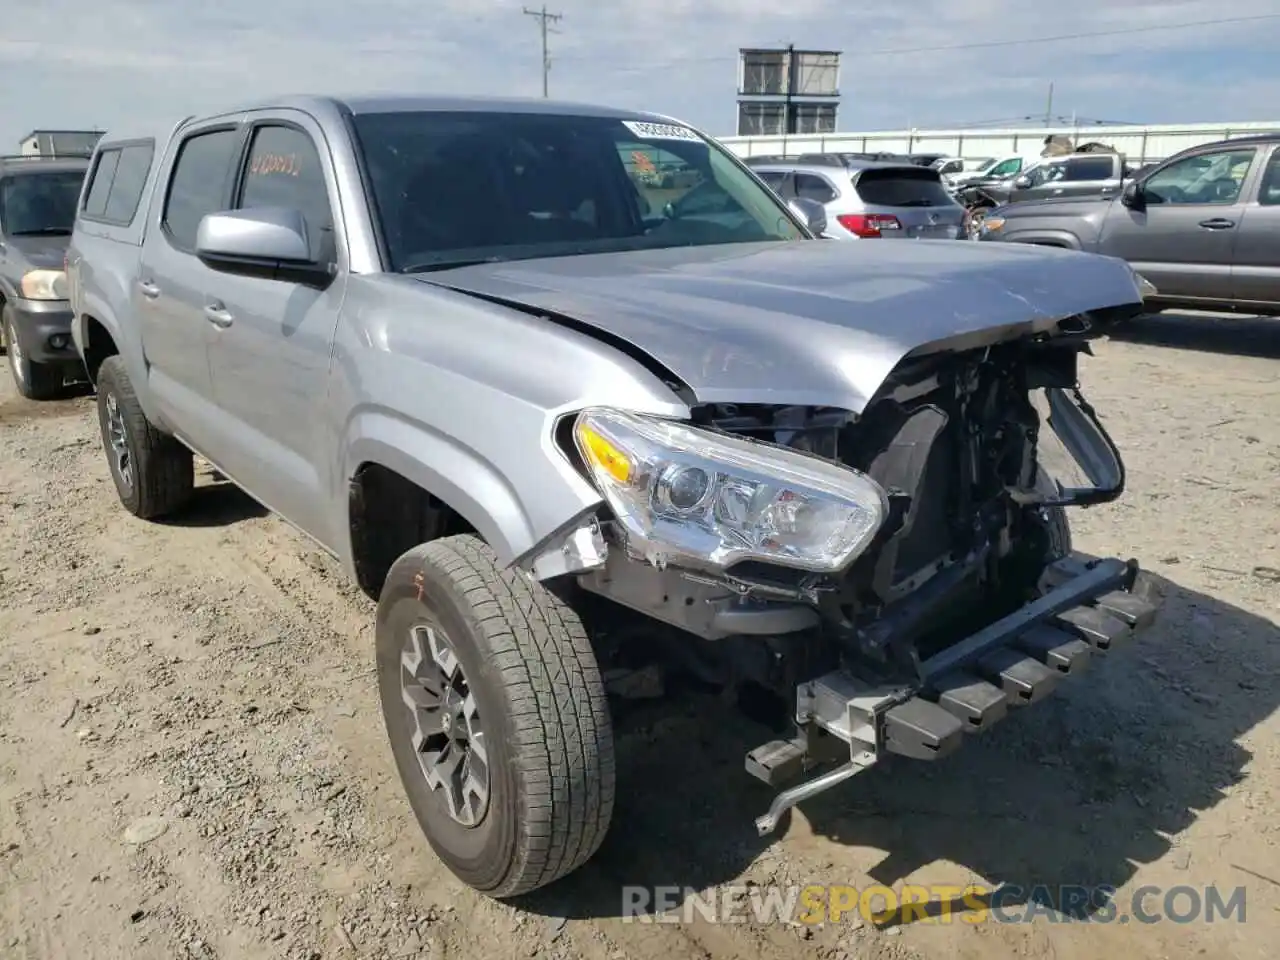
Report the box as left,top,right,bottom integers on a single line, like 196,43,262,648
97,356,196,520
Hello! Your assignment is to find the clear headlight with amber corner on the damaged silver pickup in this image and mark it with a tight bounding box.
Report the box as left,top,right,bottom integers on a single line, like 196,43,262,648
573,407,888,572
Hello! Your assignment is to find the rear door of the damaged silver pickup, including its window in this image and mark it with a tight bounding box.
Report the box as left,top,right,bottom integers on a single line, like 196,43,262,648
135,122,241,457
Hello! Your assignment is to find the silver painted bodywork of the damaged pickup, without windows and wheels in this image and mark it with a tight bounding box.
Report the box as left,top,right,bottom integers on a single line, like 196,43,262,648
69,99,1138,573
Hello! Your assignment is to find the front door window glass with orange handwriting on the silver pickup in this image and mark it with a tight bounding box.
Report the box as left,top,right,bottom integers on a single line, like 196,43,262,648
237,127,333,260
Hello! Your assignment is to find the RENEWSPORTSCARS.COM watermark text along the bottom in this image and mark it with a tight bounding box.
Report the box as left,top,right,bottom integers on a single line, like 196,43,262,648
622,883,1247,927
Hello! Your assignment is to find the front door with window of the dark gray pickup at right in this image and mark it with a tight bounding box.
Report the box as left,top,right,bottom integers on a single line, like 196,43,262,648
1098,146,1258,300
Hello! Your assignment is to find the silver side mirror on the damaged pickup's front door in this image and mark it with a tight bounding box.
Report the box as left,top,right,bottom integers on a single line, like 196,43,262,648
196,207,333,284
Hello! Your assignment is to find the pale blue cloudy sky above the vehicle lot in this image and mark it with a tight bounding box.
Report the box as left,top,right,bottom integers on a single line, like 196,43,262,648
0,0,1280,150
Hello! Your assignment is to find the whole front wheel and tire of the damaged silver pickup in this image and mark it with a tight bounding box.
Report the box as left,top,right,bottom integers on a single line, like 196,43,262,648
376,536,614,899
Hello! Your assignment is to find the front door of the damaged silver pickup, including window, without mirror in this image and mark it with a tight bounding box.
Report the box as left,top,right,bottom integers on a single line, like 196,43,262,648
202,111,346,548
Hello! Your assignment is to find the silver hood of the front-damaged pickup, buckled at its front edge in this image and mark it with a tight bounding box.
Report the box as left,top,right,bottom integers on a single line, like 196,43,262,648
415,241,1142,413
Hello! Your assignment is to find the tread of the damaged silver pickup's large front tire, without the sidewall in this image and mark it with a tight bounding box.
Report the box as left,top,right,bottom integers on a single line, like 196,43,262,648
411,535,616,897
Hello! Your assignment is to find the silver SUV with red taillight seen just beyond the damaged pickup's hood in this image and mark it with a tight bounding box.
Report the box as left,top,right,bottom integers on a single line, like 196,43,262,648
751,159,965,239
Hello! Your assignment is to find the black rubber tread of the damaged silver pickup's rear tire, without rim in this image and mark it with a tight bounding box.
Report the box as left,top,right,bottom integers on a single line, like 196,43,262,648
97,355,196,520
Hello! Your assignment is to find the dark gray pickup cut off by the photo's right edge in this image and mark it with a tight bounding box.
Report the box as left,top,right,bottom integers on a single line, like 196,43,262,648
979,134,1280,315
